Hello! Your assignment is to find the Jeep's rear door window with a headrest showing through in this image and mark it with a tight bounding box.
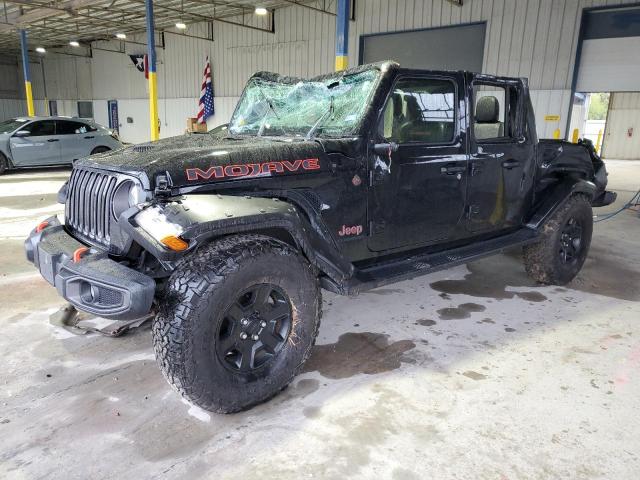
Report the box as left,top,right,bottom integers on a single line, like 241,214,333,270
473,84,518,141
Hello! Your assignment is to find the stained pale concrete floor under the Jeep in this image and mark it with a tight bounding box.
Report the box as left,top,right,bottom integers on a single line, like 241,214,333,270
0,161,640,480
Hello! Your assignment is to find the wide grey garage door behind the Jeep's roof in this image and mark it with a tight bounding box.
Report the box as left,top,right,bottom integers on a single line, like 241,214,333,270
360,22,486,72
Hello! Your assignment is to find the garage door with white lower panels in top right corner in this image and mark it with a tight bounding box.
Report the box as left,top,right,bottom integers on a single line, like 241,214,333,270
576,7,640,92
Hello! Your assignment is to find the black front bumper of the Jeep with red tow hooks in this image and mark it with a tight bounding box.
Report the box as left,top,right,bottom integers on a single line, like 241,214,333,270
24,217,156,320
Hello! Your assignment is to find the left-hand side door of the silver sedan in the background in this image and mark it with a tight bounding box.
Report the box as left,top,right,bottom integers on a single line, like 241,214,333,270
9,120,60,167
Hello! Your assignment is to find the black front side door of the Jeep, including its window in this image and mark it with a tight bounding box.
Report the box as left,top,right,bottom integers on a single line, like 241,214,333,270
369,74,468,251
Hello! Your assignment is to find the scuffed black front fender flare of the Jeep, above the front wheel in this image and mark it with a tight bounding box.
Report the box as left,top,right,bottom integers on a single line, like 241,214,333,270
124,194,354,282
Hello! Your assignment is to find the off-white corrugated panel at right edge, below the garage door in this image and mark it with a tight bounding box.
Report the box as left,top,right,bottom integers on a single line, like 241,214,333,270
602,92,640,160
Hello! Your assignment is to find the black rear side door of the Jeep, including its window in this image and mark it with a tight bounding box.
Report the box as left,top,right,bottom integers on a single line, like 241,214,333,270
467,76,535,234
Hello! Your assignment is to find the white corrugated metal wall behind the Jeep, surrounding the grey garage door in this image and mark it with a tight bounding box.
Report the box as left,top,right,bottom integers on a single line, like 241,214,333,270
1,0,634,141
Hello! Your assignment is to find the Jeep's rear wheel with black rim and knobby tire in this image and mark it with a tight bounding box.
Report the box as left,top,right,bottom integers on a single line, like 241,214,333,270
523,194,593,285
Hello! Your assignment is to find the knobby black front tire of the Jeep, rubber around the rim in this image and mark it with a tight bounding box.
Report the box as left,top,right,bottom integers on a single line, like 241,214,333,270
152,235,322,413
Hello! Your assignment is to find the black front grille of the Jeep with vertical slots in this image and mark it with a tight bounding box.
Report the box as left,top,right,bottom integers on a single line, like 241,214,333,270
65,168,118,245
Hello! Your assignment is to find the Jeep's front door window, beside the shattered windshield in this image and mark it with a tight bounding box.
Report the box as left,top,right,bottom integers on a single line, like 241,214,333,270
380,78,456,144
